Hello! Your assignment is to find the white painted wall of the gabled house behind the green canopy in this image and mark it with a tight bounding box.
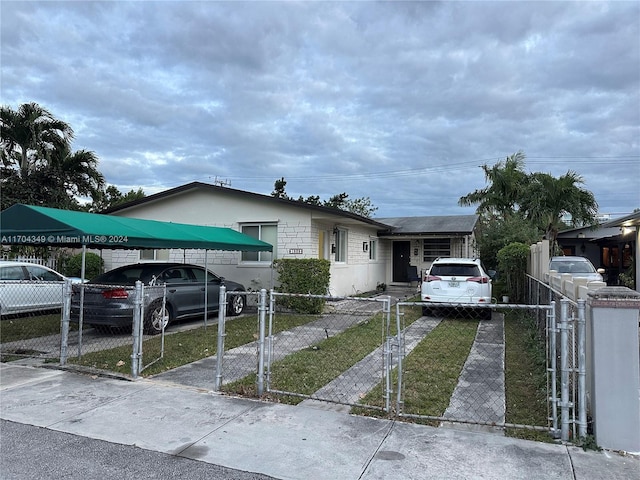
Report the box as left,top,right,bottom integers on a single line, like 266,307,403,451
103,189,389,295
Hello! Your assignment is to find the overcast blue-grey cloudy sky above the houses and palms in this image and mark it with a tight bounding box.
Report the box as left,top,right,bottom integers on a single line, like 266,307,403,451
0,0,640,217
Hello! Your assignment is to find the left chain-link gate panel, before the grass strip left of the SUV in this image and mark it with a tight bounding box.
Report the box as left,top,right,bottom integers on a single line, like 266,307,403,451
264,292,396,411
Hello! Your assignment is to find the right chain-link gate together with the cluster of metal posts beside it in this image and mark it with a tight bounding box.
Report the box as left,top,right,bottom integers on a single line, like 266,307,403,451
396,298,587,441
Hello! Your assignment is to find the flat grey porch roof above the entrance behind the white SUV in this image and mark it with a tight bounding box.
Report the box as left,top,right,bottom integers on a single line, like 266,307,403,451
376,215,478,236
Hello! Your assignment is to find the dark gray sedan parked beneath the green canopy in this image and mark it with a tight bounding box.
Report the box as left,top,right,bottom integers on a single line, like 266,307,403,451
71,263,245,334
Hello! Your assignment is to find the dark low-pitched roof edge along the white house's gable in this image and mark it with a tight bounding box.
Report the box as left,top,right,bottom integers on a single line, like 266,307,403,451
102,182,389,229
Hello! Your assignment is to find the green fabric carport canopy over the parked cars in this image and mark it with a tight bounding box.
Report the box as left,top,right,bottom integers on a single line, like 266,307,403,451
0,204,273,252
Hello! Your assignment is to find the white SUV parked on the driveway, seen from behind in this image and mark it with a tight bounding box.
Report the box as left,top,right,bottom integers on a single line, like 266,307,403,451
420,258,491,319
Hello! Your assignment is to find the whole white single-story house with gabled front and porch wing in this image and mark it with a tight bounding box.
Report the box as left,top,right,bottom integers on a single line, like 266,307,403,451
102,182,477,295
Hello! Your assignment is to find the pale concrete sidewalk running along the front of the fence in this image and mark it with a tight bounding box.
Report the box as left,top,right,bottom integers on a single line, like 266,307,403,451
0,364,640,480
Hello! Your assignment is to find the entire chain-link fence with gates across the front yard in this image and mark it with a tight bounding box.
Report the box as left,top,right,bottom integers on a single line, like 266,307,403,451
1,279,588,440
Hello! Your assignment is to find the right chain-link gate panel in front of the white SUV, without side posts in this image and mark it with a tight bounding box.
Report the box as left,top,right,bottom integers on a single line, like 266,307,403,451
396,303,551,432
